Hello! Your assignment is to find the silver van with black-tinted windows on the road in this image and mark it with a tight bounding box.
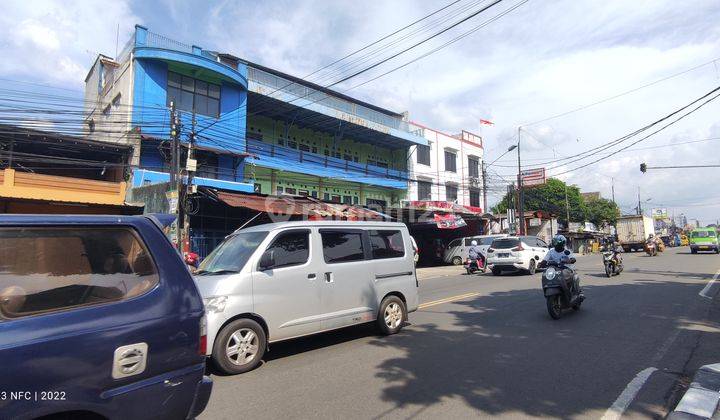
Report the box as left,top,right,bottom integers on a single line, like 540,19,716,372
195,221,418,374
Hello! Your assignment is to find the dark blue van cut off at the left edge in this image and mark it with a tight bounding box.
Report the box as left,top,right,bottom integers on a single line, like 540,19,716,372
0,215,212,419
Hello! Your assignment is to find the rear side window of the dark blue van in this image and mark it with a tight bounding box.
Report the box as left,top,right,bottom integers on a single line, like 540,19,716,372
0,227,159,318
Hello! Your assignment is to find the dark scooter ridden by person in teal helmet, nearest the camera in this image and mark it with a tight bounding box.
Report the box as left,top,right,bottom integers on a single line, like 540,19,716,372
542,253,585,319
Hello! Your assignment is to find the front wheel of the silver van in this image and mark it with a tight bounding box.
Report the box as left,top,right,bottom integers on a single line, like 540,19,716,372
217,319,267,375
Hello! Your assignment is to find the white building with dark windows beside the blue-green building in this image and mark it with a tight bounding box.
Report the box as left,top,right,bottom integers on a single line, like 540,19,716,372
407,122,486,211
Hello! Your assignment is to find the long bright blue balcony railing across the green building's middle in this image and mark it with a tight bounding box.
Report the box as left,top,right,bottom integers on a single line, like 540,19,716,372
247,139,408,181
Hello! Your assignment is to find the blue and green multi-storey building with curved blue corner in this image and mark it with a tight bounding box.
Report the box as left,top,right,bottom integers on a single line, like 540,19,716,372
85,26,427,254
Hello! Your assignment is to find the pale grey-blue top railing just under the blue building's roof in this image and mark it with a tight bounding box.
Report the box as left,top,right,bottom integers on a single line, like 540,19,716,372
248,67,408,131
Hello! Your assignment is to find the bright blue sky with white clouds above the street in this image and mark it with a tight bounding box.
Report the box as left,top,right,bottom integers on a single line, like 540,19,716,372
0,0,720,223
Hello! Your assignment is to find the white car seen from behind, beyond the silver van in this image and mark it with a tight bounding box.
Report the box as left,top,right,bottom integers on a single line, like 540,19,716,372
487,236,548,276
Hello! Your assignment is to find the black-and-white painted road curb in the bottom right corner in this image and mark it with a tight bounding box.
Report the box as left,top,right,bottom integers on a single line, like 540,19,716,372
667,363,720,420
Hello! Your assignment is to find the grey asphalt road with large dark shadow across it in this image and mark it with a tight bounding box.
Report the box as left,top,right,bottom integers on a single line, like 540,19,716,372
201,248,720,419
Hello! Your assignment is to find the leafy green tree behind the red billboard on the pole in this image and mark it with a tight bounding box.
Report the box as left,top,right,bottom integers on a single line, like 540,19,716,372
493,178,587,225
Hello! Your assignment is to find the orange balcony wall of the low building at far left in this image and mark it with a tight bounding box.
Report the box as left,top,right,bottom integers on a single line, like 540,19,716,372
0,169,126,205
